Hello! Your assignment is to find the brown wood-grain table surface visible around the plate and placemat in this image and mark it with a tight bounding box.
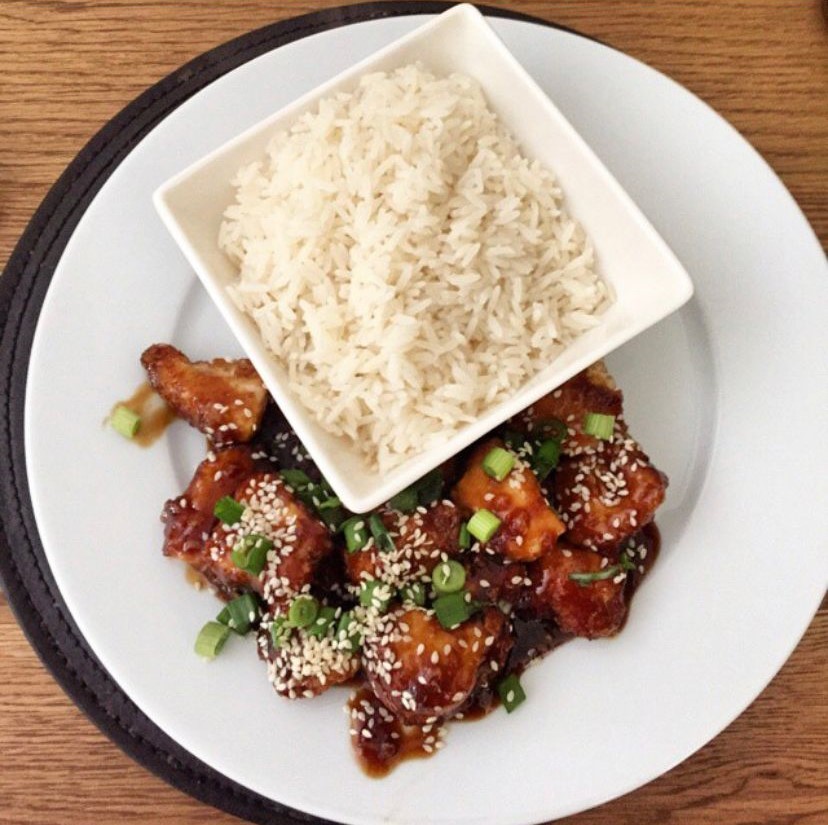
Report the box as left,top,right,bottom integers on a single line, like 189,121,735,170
0,0,828,825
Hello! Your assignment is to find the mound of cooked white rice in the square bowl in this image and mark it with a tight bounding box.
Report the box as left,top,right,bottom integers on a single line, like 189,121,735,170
219,65,611,472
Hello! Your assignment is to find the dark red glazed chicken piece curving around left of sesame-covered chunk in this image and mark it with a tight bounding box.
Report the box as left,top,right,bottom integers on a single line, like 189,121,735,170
161,440,254,597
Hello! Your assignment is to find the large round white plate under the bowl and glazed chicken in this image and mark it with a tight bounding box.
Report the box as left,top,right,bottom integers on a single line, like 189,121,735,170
26,12,828,825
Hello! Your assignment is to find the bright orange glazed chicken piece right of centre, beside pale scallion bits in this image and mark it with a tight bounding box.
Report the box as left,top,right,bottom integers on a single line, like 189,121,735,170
454,439,564,561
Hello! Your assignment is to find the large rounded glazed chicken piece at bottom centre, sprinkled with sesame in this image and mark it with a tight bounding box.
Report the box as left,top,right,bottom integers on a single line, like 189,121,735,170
363,607,511,724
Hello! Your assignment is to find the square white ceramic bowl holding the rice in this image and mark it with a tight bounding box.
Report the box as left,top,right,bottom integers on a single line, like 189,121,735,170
153,4,693,513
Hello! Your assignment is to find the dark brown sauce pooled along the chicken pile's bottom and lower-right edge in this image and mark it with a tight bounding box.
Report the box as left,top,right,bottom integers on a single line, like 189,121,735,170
348,523,661,778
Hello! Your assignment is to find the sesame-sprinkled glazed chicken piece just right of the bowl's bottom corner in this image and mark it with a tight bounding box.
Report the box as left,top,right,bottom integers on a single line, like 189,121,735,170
345,501,461,588
